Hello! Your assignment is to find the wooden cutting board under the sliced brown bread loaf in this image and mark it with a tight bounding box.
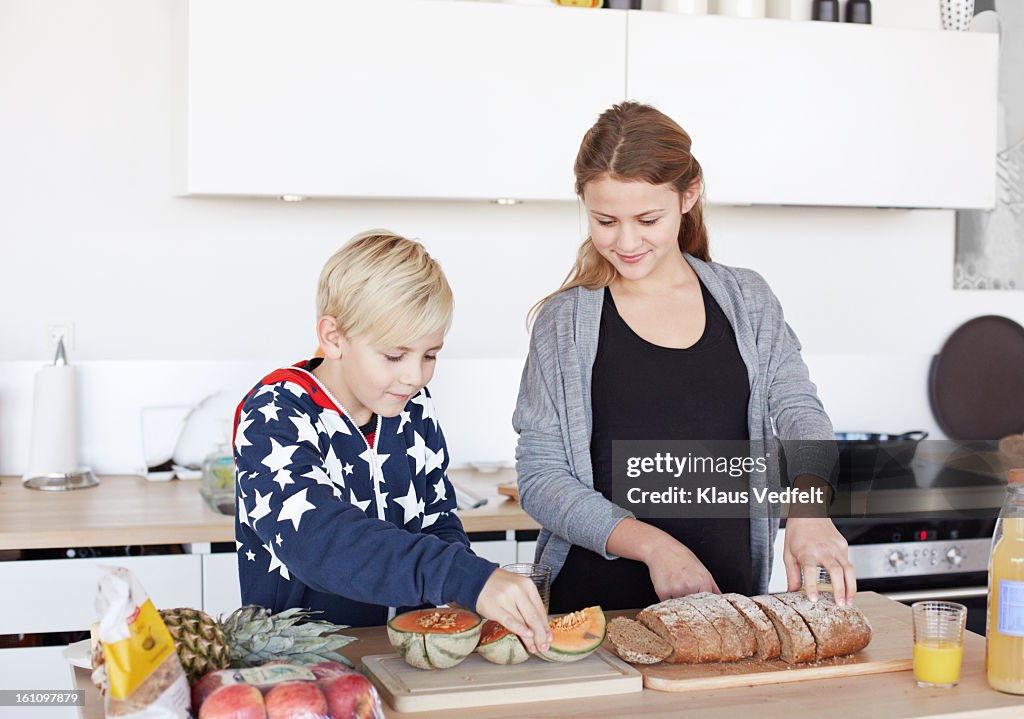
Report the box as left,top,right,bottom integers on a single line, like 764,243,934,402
637,592,913,691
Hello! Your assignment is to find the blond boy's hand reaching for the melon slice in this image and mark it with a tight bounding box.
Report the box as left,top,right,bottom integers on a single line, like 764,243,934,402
476,569,551,654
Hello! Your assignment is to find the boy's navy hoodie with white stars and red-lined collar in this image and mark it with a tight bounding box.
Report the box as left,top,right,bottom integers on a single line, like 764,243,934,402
234,360,497,627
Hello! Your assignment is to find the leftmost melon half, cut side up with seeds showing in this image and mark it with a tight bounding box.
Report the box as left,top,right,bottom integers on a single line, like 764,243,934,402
387,607,483,669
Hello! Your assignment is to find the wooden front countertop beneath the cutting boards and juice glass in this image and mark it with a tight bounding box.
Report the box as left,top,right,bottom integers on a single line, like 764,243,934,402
76,606,1024,719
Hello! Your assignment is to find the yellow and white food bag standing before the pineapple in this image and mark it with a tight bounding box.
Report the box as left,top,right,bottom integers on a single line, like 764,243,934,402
96,566,191,719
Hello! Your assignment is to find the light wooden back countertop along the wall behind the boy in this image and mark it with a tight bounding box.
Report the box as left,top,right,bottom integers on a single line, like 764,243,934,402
0,469,539,551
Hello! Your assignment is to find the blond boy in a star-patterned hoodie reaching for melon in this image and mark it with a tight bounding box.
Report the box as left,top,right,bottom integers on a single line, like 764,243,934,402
234,230,547,647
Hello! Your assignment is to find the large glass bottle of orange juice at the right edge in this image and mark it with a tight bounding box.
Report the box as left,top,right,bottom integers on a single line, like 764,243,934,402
985,469,1024,694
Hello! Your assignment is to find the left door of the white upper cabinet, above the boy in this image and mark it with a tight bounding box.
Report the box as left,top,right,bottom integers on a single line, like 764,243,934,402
175,0,627,200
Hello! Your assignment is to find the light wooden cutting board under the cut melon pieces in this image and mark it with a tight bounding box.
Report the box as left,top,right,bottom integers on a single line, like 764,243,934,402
362,649,643,712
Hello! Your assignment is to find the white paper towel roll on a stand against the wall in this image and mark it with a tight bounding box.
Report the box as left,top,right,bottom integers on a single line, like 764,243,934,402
25,365,79,477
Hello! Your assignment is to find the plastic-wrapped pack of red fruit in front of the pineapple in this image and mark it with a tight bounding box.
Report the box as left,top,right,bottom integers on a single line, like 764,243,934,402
193,662,384,719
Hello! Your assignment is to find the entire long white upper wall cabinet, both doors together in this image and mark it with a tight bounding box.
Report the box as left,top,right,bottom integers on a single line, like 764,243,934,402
175,0,997,208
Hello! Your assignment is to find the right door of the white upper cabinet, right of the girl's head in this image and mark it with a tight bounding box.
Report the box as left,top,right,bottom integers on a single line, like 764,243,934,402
627,12,998,208
